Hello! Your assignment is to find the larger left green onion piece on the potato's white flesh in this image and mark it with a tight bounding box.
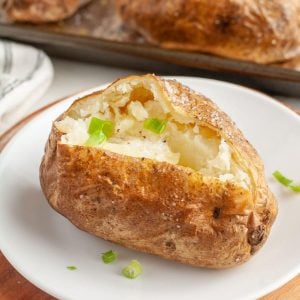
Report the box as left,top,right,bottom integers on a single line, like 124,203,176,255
85,117,114,146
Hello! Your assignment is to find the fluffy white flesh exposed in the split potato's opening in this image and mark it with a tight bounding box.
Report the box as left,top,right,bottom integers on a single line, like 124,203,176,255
55,79,249,188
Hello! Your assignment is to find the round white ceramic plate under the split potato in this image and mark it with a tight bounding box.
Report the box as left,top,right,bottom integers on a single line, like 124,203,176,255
0,77,300,300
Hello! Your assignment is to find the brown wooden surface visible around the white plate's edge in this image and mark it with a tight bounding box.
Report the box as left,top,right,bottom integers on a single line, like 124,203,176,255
0,99,300,300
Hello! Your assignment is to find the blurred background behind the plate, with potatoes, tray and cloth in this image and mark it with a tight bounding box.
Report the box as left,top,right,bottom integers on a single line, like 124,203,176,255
0,0,300,132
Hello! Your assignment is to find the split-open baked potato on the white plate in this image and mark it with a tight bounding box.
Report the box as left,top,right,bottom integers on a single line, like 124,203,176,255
40,74,277,268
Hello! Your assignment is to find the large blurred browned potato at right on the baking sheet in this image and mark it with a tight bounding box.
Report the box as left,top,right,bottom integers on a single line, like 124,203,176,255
115,0,300,63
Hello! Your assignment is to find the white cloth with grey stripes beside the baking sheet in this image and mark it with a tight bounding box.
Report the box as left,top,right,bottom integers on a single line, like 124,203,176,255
0,40,53,134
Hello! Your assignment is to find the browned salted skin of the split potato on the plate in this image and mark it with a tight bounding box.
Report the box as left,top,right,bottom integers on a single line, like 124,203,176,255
40,75,277,268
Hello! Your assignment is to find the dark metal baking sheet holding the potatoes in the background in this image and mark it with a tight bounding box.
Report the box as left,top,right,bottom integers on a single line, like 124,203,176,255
0,1,300,96
